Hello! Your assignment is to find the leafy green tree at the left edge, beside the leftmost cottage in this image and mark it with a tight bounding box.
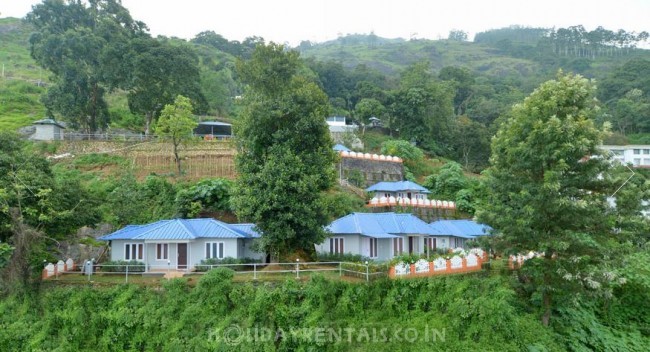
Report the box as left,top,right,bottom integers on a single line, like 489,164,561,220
0,133,99,289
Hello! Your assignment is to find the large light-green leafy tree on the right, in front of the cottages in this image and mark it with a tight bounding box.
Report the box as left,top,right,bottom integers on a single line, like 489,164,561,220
477,73,636,325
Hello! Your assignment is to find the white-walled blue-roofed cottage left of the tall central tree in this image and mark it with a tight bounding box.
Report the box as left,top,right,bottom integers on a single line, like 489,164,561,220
99,219,266,271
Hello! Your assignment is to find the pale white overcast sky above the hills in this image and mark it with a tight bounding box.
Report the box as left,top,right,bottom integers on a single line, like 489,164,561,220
0,0,650,45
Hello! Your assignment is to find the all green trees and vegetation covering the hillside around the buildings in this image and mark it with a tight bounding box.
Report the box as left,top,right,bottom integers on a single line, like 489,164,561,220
0,0,650,351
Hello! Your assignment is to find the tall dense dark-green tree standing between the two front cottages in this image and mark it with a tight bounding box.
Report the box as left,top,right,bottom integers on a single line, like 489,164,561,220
233,43,335,258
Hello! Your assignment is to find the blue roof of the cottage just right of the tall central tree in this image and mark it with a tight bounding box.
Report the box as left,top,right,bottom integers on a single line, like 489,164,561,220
326,213,438,238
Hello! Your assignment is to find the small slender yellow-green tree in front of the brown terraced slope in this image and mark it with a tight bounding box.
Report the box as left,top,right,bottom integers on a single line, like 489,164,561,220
156,95,199,176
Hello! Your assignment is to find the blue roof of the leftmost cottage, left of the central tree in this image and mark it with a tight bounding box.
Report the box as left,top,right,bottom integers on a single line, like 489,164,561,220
99,219,259,241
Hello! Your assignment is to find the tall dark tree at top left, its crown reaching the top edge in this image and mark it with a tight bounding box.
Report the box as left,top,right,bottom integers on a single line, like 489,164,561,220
26,0,146,132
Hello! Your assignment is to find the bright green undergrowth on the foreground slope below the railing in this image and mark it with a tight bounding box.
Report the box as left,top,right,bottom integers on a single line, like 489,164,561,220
0,276,566,351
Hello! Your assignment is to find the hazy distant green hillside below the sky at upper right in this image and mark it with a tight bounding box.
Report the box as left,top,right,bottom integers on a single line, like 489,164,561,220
298,35,650,88
